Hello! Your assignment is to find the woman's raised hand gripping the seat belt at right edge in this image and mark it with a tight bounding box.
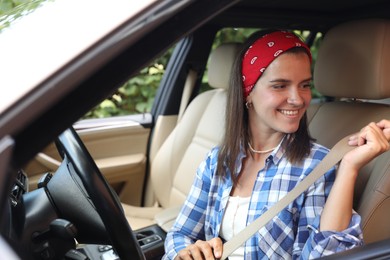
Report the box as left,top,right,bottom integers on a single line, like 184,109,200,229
343,120,390,170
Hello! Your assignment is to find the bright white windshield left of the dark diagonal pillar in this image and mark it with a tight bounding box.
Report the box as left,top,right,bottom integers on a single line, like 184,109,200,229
0,0,155,114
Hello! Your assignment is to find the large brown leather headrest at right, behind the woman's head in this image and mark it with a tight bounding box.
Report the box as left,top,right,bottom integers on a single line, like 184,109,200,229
314,19,390,99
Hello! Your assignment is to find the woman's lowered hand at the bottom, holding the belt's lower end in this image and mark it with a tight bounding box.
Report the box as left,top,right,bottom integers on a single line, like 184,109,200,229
175,237,223,260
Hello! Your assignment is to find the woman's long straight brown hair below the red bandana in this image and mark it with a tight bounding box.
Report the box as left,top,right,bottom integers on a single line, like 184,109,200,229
217,30,314,182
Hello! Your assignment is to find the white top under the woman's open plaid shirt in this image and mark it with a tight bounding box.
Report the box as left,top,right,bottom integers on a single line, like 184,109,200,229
220,196,251,260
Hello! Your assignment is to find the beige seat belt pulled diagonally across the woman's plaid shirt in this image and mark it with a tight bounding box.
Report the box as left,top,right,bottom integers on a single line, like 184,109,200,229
221,136,354,260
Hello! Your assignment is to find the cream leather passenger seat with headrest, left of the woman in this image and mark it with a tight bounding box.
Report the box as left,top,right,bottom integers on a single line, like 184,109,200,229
123,44,239,230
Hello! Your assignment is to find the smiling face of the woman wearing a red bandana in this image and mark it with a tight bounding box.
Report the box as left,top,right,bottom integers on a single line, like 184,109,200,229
247,52,312,133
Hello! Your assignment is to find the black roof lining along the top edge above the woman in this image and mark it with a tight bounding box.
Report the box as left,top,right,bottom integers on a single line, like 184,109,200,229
214,0,390,31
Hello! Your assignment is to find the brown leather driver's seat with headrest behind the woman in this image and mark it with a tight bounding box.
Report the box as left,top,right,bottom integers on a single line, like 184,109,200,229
309,20,390,243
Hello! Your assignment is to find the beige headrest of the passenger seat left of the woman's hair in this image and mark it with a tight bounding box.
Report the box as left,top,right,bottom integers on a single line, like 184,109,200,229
208,43,240,89
